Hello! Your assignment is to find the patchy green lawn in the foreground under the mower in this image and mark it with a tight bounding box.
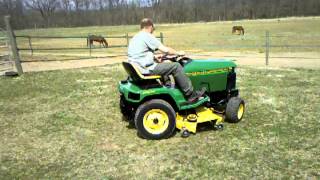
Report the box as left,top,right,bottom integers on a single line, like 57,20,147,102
0,65,320,179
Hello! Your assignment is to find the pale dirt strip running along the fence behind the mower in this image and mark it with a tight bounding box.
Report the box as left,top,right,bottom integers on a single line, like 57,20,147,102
22,52,320,72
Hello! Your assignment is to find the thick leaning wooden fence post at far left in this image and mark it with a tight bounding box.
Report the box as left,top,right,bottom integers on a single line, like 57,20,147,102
4,16,23,75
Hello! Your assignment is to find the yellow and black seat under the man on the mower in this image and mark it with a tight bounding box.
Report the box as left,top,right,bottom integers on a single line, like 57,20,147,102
122,62,161,81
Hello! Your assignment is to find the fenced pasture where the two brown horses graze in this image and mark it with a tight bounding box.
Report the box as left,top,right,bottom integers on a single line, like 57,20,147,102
9,17,320,60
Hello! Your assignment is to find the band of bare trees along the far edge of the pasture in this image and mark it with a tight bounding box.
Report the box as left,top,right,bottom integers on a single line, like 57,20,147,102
0,0,320,28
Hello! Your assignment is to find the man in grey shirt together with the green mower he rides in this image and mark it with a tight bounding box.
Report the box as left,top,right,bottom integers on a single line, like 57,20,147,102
118,19,245,139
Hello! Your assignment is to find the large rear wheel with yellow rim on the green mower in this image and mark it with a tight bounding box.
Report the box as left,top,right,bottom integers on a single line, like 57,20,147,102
134,99,176,139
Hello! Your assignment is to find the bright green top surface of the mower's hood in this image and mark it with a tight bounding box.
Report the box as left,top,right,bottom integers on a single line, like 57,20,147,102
184,59,237,73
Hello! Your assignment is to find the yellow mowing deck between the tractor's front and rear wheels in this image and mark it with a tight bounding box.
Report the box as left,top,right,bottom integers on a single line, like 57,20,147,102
176,107,224,133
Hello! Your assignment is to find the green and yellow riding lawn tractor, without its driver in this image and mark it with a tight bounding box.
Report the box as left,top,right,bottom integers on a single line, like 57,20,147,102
118,56,245,139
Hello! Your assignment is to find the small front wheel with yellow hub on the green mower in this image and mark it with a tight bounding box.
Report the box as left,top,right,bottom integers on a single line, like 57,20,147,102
226,97,245,123
